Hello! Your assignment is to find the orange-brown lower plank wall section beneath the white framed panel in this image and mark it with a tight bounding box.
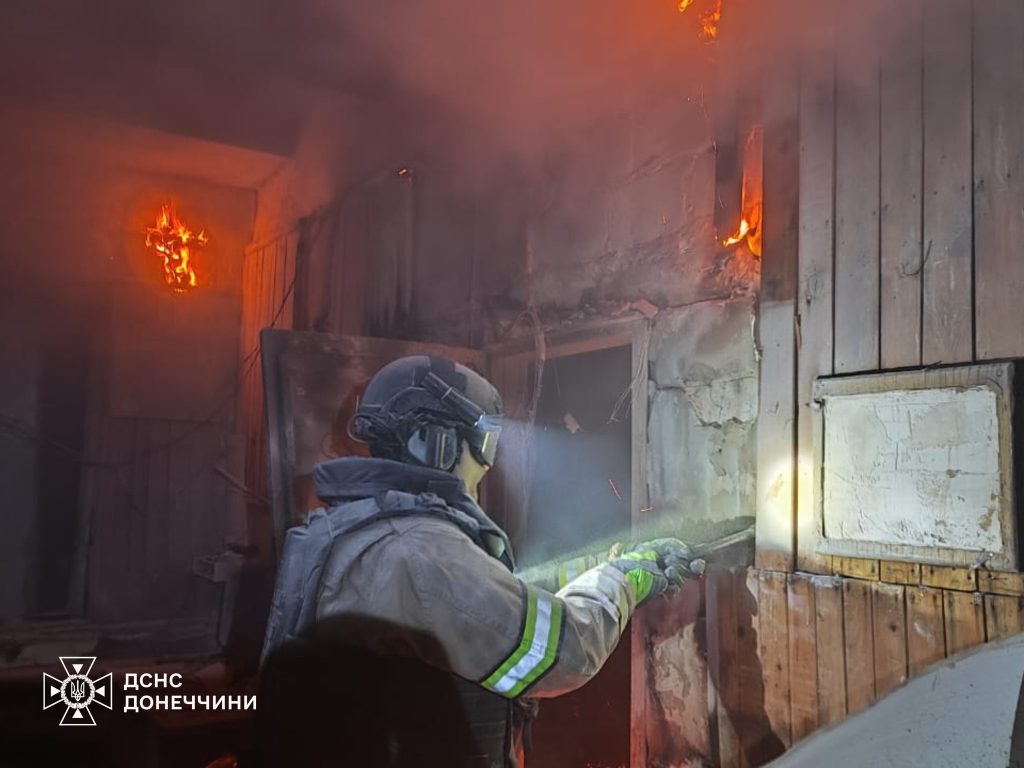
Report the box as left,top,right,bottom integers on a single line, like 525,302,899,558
707,558,1024,768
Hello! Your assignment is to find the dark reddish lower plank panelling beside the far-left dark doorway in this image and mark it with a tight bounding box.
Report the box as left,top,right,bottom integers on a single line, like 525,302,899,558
85,416,228,621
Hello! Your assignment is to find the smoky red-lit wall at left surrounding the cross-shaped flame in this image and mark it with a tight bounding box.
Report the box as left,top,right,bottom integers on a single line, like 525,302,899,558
0,114,255,621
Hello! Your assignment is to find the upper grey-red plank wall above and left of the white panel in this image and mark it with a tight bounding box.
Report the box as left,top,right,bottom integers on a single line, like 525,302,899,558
757,0,1024,593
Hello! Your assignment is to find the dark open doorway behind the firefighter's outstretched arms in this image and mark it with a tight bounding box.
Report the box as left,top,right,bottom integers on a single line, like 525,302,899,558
521,346,633,768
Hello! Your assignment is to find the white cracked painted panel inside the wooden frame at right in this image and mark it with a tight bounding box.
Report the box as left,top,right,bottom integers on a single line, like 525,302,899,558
823,386,1004,551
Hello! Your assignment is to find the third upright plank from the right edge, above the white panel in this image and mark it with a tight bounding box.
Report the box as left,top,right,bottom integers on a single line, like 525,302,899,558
880,0,923,369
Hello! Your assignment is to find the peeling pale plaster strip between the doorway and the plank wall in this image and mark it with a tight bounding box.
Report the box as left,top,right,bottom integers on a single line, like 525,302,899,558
635,295,759,768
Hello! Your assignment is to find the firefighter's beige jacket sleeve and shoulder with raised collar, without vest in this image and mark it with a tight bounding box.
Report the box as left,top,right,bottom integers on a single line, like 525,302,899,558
315,459,636,698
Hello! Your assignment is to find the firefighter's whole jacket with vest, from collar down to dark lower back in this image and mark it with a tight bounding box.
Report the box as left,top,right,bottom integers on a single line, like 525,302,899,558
261,458,637,768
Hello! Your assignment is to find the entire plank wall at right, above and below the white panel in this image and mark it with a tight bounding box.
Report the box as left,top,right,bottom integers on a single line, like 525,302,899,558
724,0,1024,766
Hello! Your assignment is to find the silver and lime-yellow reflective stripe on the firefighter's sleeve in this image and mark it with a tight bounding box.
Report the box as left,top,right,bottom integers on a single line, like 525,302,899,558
481,587,563,698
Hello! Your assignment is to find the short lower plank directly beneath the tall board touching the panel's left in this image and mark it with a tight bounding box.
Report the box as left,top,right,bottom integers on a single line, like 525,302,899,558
787,573,818,743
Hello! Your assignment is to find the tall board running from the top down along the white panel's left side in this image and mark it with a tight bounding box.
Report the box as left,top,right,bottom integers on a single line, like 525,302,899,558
797,0,836,572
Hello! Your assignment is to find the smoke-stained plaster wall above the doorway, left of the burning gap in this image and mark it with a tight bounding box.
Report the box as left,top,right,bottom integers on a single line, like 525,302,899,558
513,94,756,314
